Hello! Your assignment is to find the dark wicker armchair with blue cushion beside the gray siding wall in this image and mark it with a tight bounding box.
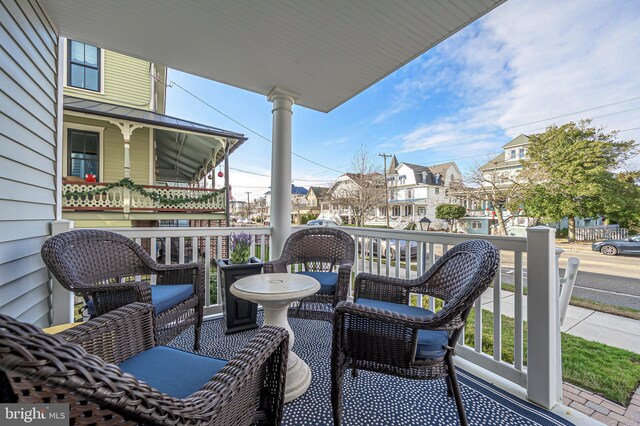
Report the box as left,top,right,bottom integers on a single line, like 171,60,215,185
41,229,205,350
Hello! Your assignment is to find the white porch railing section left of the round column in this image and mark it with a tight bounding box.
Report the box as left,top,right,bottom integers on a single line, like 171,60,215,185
94,227,271,315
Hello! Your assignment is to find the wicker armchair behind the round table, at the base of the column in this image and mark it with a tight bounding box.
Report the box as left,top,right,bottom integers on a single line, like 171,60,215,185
264,227,355,321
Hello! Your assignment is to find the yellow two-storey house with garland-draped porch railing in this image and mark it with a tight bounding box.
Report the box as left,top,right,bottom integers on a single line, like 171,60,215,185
62,39,246,227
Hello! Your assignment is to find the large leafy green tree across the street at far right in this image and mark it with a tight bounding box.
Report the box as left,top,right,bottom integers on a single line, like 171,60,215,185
519,120,638,241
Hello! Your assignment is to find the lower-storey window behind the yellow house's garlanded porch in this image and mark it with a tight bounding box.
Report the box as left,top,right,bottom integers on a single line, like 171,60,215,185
67,129,100,182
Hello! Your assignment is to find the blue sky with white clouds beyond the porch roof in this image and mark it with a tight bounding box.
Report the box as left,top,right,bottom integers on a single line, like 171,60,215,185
167,0,640,199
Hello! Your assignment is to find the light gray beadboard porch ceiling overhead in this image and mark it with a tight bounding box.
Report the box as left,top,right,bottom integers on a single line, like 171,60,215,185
41,0,505,112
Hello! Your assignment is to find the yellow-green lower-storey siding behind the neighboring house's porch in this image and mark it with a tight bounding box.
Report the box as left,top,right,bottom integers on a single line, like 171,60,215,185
63,114,155,185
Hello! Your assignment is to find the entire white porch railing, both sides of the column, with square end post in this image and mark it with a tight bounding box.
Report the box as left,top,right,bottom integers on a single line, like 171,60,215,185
54,221,562,408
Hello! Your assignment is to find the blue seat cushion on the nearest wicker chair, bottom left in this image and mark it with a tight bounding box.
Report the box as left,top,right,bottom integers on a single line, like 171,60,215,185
118,346,227,399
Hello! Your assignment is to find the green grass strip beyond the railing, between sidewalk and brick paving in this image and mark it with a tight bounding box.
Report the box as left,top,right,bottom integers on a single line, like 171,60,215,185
465,310,640,406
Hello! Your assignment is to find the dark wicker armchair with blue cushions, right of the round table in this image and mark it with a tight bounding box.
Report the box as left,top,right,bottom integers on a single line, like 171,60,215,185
331,240,500,425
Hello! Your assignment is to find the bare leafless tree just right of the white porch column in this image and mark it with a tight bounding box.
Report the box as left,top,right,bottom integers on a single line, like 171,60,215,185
331,146,384,226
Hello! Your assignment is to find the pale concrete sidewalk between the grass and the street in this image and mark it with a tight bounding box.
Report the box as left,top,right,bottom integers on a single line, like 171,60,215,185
482,288,640,353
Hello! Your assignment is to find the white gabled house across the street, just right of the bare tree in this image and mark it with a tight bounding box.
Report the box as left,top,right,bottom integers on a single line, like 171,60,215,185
367,156,462,229
